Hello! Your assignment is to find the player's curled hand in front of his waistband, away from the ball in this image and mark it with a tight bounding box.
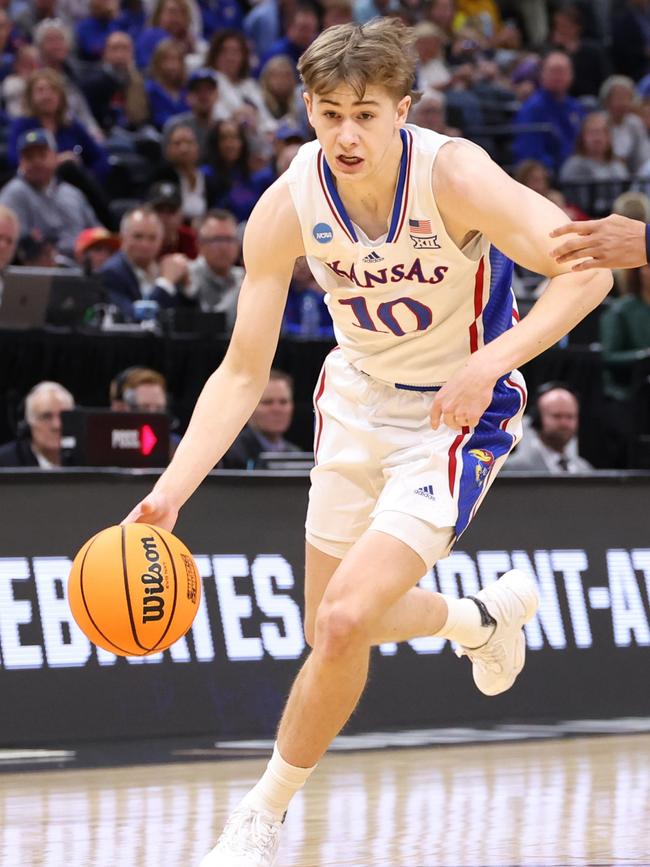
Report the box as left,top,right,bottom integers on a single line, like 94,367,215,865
431,362,494,430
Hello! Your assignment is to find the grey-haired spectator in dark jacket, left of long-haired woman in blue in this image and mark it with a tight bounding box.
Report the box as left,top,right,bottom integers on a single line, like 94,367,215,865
83,30,149,134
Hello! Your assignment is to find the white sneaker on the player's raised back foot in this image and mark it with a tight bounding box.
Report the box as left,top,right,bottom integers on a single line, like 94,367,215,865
456,569,539,695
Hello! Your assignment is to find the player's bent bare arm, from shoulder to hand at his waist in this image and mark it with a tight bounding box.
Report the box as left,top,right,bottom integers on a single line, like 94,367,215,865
432,142,612,428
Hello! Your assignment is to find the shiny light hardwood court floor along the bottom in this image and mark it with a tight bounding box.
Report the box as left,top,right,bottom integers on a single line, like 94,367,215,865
0,735,650,867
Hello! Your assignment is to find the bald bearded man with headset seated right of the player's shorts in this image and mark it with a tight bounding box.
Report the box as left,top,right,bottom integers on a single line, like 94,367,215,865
507,382,592,475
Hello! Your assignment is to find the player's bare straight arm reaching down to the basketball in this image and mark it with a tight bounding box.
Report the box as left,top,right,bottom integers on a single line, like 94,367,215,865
125,178,304,529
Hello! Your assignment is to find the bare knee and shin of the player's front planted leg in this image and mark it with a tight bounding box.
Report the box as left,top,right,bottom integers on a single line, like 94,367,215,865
278,532,426,768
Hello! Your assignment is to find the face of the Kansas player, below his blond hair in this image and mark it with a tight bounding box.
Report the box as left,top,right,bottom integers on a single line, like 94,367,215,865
305,84,404,181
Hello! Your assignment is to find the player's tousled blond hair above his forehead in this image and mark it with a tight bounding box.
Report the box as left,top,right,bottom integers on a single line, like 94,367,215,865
298,18,419,102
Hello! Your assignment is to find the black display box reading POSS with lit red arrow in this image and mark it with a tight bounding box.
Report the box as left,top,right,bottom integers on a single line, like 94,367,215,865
61,408,169,469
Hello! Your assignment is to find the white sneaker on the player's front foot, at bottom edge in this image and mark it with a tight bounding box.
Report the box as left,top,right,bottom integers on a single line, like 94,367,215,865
199,803,284,867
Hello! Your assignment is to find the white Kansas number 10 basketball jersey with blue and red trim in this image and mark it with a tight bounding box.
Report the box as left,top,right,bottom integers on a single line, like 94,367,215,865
285,125,518,386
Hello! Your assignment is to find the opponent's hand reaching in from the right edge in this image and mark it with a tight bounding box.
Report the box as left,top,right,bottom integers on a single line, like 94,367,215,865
551,214,647,271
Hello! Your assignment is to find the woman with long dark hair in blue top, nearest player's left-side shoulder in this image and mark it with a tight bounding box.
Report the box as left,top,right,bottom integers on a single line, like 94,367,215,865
208,120,258,221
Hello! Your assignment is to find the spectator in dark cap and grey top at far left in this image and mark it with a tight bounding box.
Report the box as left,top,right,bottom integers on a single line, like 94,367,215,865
0,129,99,259
